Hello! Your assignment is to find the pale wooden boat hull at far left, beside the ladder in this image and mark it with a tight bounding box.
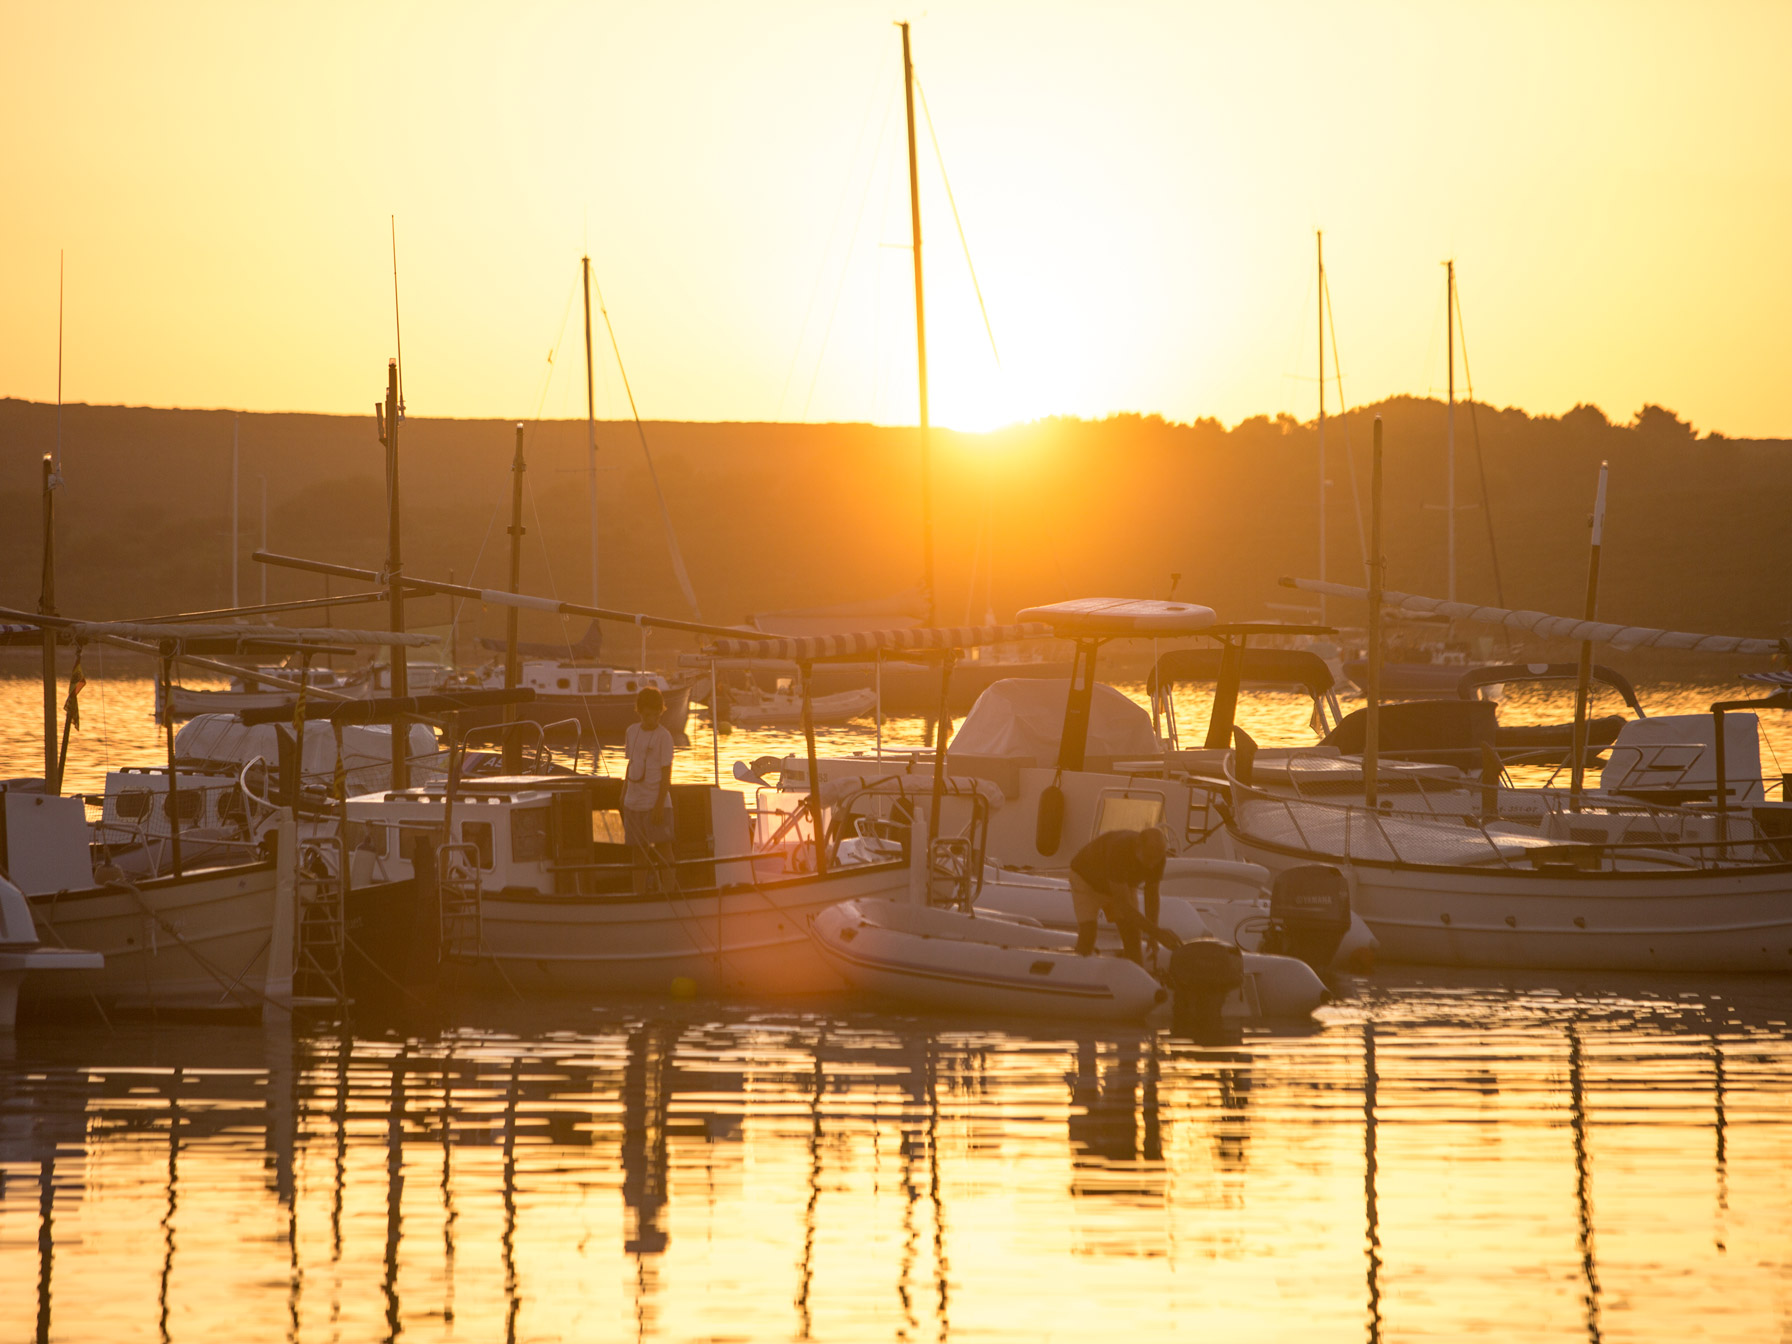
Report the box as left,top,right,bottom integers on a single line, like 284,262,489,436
20,862,285,1011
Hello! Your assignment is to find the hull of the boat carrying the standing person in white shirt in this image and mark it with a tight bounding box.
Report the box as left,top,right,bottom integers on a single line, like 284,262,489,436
448,864,909,996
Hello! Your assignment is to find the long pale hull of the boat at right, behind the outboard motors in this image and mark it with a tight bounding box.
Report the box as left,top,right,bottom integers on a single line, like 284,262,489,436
1233,830,1792,975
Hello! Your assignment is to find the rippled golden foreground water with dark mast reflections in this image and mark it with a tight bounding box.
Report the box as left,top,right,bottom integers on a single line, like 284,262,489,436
0,977,1792,1342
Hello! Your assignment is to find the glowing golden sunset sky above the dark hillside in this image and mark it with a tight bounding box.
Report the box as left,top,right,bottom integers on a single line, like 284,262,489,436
0,0,1792,435
